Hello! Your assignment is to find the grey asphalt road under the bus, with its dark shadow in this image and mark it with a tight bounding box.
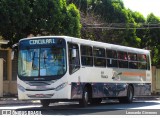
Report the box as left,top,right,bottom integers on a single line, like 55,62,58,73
0,99,160,115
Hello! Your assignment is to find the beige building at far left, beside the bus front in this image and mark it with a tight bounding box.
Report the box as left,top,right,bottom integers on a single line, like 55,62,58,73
0,38,18,95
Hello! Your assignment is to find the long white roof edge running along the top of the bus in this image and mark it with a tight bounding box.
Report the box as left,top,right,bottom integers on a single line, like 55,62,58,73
19,36,150,54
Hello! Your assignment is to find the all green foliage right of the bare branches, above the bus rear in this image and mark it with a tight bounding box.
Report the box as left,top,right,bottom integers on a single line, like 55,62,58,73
67,0,160,66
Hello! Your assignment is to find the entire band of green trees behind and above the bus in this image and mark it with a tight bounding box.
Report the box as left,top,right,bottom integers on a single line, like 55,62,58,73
0,0,160,66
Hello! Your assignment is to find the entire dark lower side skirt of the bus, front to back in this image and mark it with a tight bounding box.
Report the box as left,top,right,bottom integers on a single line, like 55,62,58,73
71,83,151,99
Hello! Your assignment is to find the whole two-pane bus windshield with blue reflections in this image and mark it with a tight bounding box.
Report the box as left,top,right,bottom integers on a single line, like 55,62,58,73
18,46,66,77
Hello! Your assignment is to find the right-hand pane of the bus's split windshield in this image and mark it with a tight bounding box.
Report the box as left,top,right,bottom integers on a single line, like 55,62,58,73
39,47,66,76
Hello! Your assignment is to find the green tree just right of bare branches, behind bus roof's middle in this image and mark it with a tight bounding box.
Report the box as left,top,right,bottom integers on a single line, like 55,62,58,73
84,0,139,47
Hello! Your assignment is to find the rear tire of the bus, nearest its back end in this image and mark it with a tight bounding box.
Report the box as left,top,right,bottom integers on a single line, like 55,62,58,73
119,85,134,103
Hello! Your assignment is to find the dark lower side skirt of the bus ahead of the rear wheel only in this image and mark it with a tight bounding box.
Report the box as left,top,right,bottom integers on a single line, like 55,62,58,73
71,83,128,99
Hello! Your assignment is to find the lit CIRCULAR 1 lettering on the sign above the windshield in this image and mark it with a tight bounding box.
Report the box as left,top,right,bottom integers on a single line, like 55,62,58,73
29,39,55,45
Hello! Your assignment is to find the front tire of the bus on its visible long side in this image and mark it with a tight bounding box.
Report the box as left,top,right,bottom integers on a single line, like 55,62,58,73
79,87,89,107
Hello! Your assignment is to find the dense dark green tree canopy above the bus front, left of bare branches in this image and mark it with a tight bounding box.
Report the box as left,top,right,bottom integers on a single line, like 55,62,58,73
0,0,81,44
